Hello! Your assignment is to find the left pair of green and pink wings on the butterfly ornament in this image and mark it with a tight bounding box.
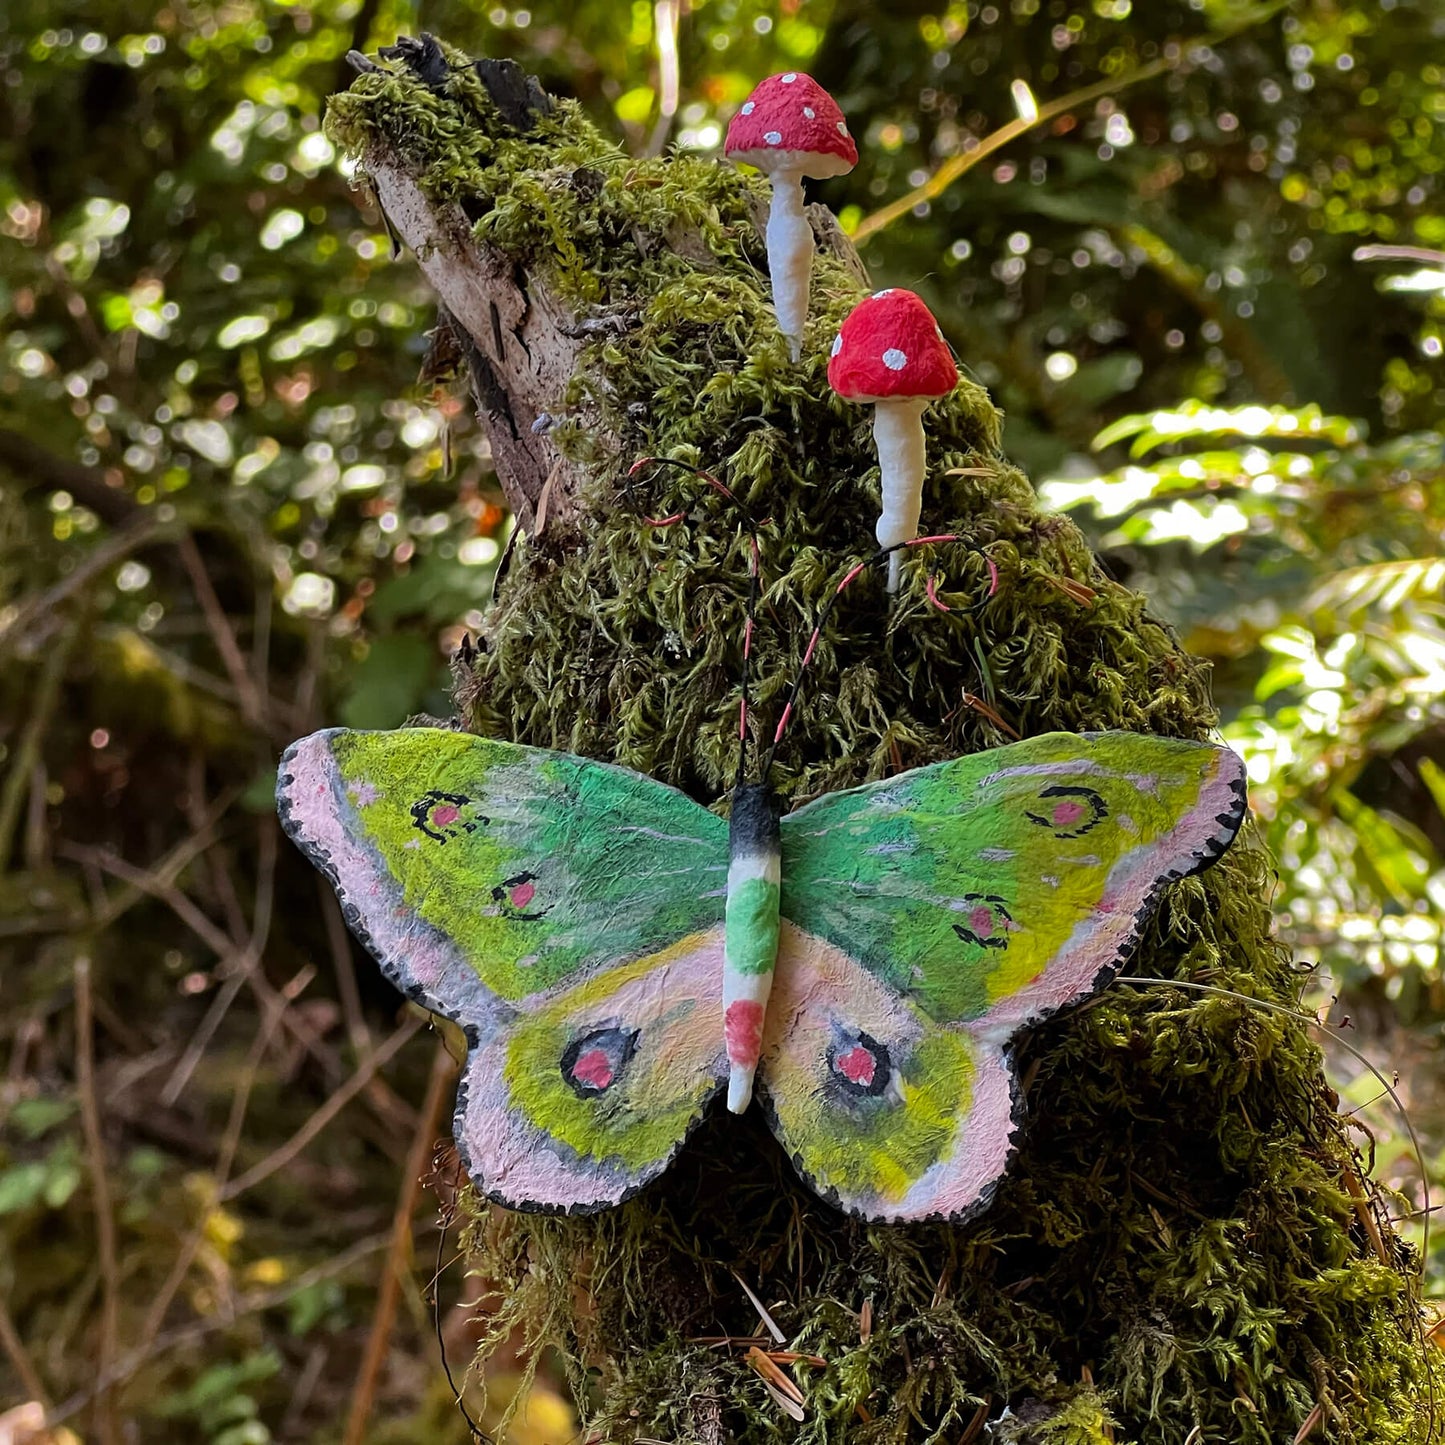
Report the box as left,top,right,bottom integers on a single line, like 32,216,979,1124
277,728,727,1209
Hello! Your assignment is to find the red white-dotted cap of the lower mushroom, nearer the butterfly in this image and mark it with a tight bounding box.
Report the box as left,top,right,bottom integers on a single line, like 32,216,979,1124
828,289,958,402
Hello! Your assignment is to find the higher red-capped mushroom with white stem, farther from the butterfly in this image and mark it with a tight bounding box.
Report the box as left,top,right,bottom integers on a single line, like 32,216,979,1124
723,71,858,361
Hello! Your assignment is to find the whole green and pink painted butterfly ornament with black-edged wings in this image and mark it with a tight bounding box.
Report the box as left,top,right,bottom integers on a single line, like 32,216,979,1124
277,538,1246,1221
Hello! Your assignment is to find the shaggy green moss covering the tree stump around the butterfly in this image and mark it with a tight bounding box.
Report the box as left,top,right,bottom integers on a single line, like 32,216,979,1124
332,39,1435,1445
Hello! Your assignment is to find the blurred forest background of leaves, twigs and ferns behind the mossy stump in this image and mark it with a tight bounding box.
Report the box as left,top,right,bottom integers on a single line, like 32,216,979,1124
0,0,1445,1445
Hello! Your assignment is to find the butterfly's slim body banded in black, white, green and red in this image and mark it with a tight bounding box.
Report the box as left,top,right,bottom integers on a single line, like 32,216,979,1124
723,783,782,1114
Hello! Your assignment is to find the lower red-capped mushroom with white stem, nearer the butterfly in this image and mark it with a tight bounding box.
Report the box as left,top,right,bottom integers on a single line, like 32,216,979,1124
828,289,958,592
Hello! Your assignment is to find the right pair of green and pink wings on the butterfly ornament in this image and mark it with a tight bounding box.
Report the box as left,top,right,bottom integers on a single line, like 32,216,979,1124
760,733,1246,1218
